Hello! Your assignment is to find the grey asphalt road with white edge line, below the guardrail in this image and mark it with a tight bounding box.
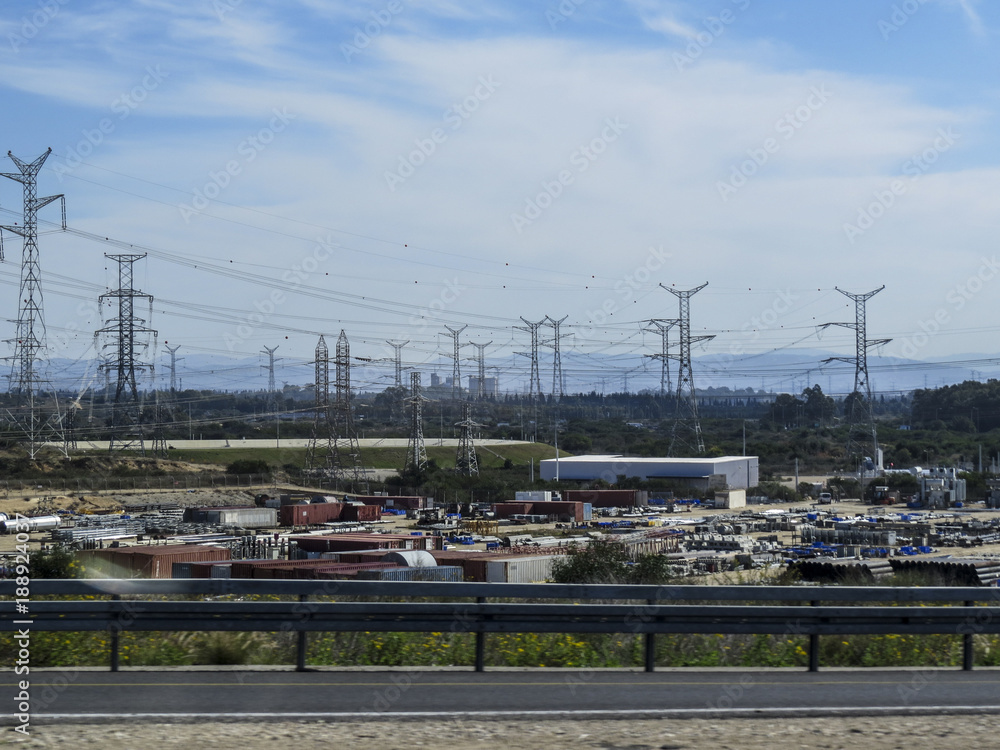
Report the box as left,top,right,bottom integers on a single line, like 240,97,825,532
0,669,1000,724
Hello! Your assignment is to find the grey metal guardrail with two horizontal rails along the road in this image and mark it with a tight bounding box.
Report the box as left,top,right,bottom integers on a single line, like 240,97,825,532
0,579,1000,672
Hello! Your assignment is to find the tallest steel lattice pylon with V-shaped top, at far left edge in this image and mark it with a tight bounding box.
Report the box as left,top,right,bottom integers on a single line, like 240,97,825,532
0,148,67,458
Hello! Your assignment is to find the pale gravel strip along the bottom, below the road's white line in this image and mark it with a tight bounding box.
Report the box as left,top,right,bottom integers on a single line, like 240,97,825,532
0,714,996,750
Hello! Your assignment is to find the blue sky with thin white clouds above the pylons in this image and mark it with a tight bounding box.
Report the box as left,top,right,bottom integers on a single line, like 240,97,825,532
0,0,1000,396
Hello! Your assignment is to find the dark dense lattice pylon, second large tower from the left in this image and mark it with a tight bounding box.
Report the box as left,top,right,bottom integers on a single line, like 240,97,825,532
94,254,166,455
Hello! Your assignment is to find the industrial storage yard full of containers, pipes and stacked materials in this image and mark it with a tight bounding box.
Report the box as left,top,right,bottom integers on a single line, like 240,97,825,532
0,478,1000,586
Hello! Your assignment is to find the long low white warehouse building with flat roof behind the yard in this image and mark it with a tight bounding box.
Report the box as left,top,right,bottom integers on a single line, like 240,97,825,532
541,456,759,490
